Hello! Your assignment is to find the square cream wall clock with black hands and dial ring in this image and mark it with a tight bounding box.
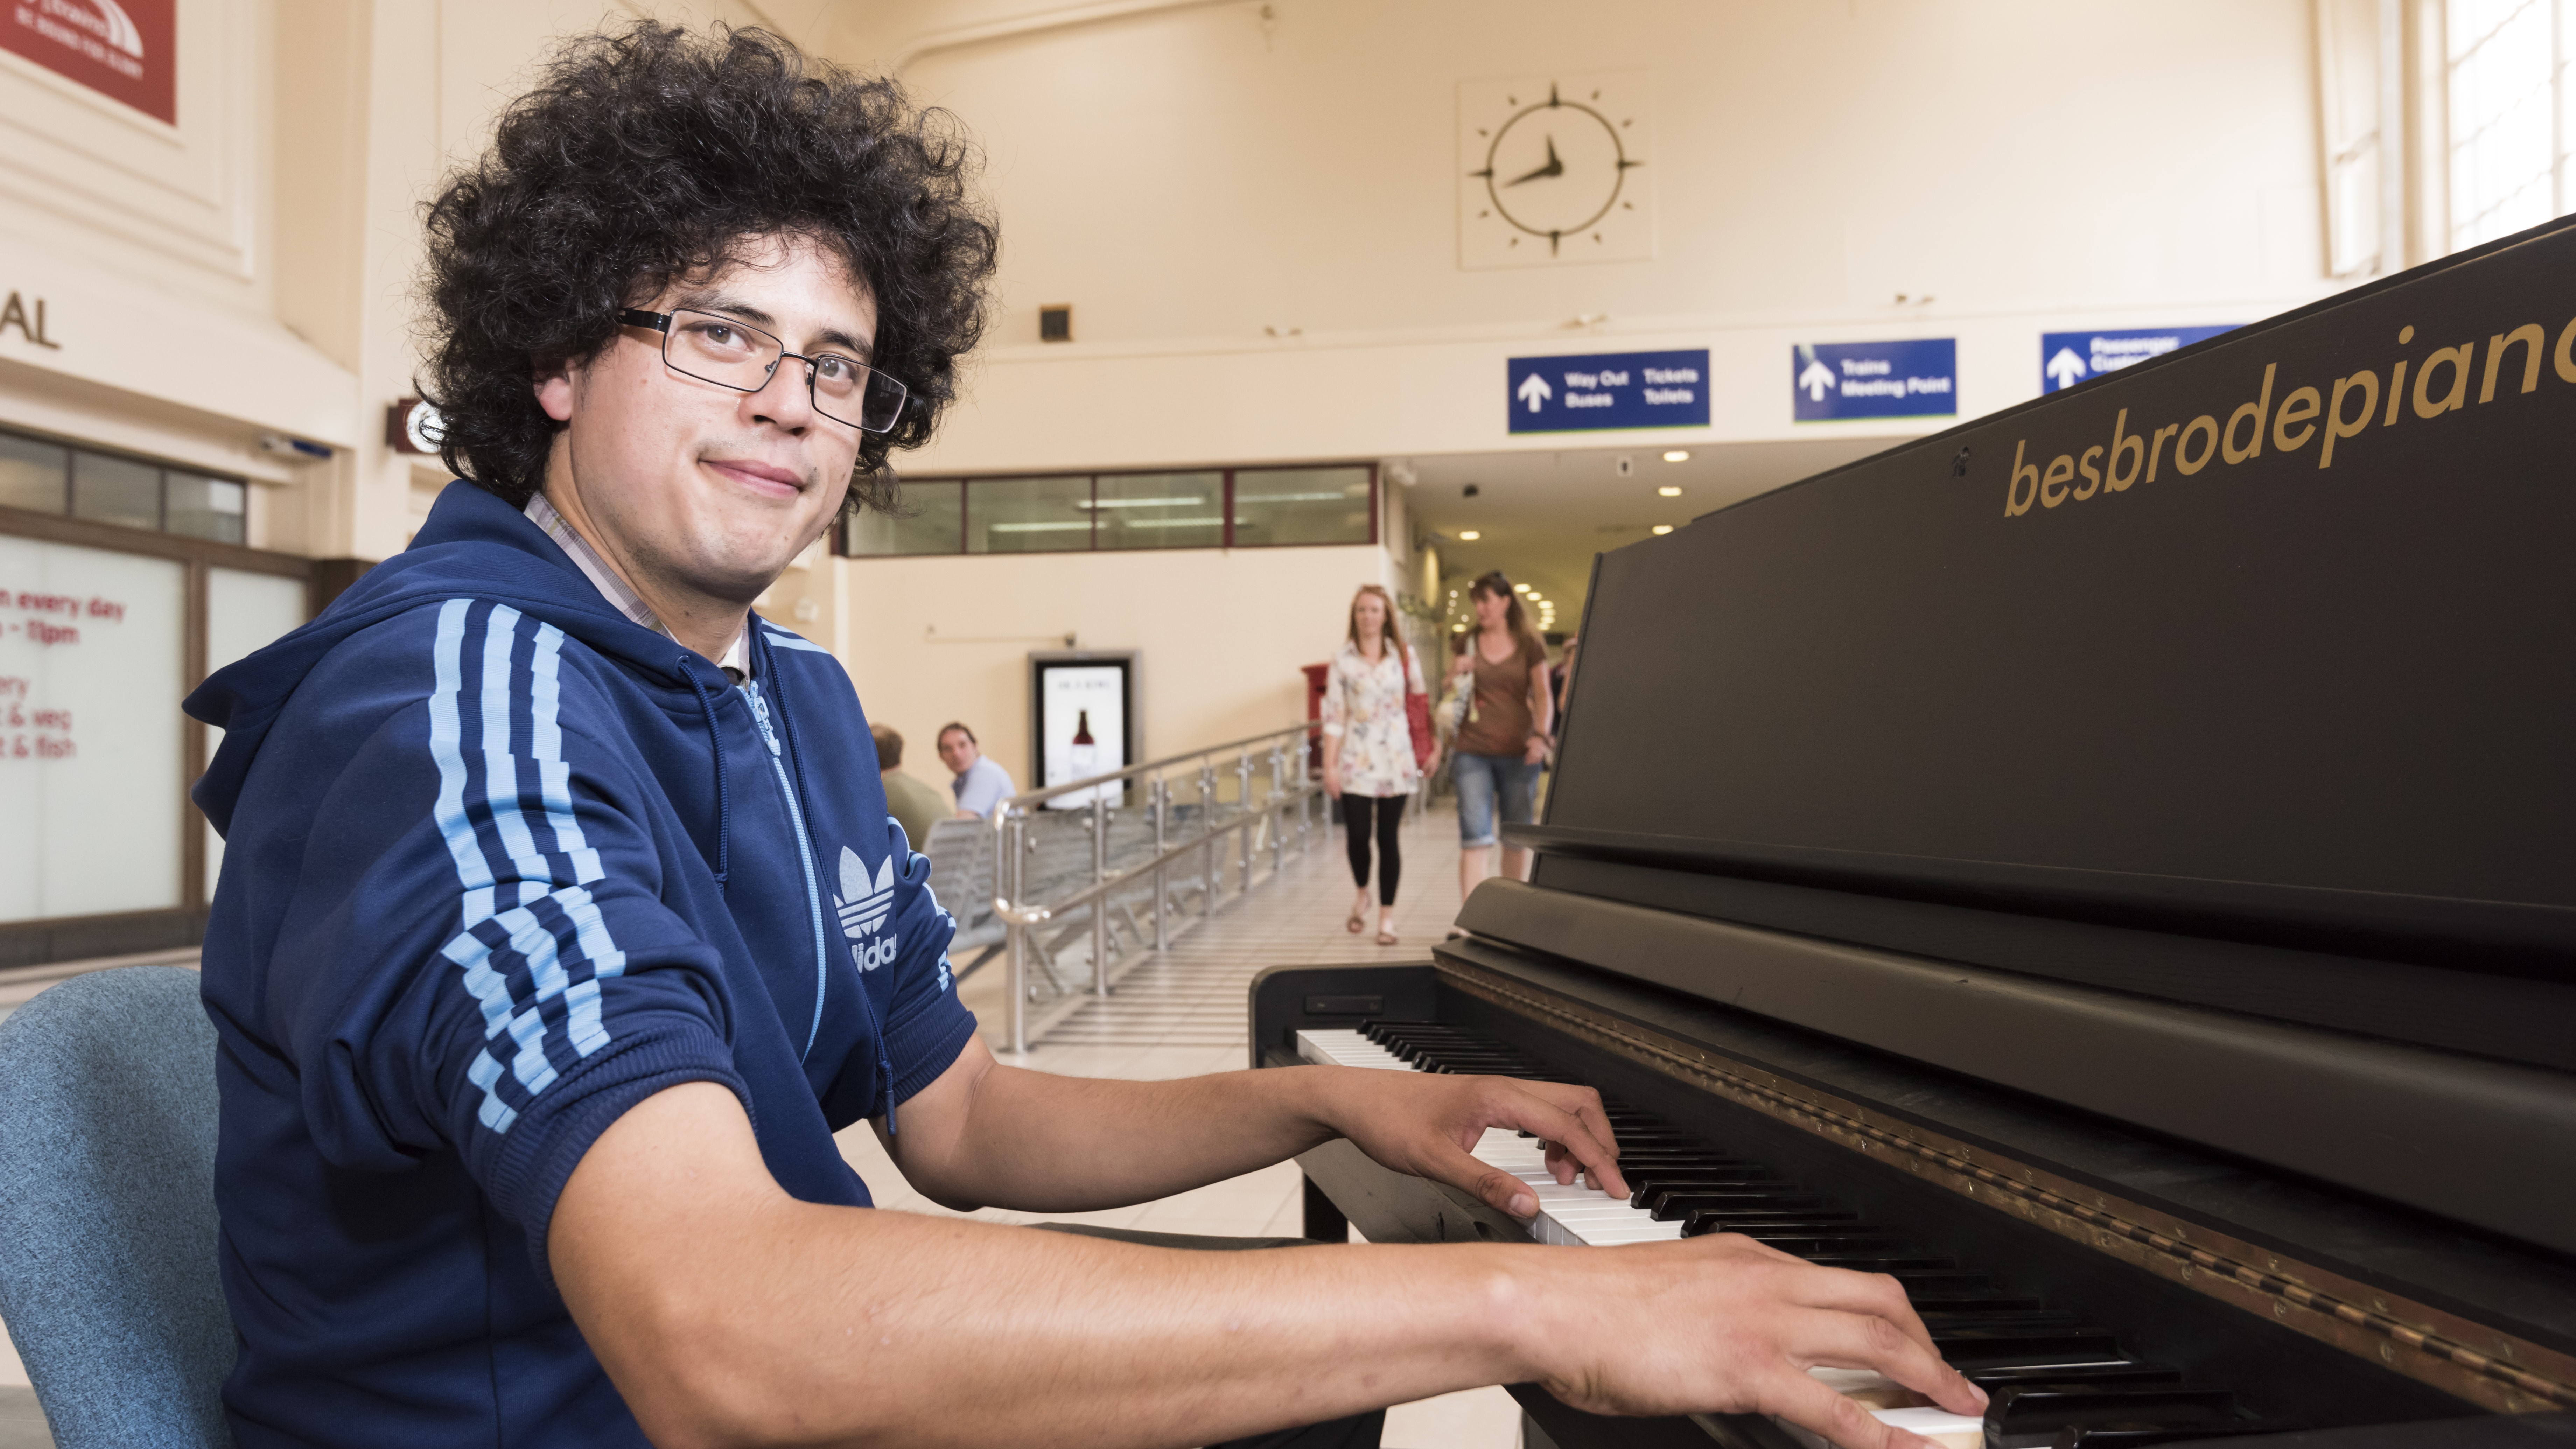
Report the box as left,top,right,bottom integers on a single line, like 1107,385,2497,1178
1458,72,1654,268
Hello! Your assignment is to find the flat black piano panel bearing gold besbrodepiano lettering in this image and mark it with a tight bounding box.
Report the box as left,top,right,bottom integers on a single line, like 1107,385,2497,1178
1530,214,2576,982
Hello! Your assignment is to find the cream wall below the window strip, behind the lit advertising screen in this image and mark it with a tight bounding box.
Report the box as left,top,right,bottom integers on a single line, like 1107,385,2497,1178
834,544,1396,789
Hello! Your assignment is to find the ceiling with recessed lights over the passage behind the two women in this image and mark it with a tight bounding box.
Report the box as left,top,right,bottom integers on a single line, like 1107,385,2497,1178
1386,428,1906,634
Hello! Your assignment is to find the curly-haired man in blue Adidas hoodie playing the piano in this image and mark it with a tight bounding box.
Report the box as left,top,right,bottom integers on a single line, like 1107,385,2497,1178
188,23,1978,1449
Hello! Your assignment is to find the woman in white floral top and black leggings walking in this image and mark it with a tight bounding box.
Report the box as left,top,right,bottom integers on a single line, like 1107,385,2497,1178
1324,583,1440,946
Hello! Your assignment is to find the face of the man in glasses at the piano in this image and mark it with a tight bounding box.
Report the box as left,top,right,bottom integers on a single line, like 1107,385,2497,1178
536,237,876,614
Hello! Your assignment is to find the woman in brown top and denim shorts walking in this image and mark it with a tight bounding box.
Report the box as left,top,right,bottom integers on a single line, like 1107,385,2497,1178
1450,570,1556,897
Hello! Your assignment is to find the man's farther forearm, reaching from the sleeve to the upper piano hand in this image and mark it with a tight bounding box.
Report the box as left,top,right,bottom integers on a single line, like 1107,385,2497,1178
886,1044,1339,1212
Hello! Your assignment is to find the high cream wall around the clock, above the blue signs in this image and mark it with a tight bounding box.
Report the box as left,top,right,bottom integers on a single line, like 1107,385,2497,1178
835,0,2326,472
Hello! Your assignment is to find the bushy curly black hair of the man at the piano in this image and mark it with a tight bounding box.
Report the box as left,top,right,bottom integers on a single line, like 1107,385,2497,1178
422,21,997,508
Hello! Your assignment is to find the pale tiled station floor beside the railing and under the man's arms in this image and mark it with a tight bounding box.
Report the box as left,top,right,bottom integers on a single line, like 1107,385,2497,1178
840,794,1520,1449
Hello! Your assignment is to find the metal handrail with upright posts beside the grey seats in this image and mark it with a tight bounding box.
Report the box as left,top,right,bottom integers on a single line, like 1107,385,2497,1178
992,719,1322,1052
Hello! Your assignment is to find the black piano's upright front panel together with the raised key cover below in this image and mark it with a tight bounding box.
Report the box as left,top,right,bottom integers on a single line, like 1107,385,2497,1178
1504,214,2576,1253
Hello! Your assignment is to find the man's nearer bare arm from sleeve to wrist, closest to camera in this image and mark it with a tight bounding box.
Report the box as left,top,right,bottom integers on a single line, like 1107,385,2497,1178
551,1083,1553,1447
